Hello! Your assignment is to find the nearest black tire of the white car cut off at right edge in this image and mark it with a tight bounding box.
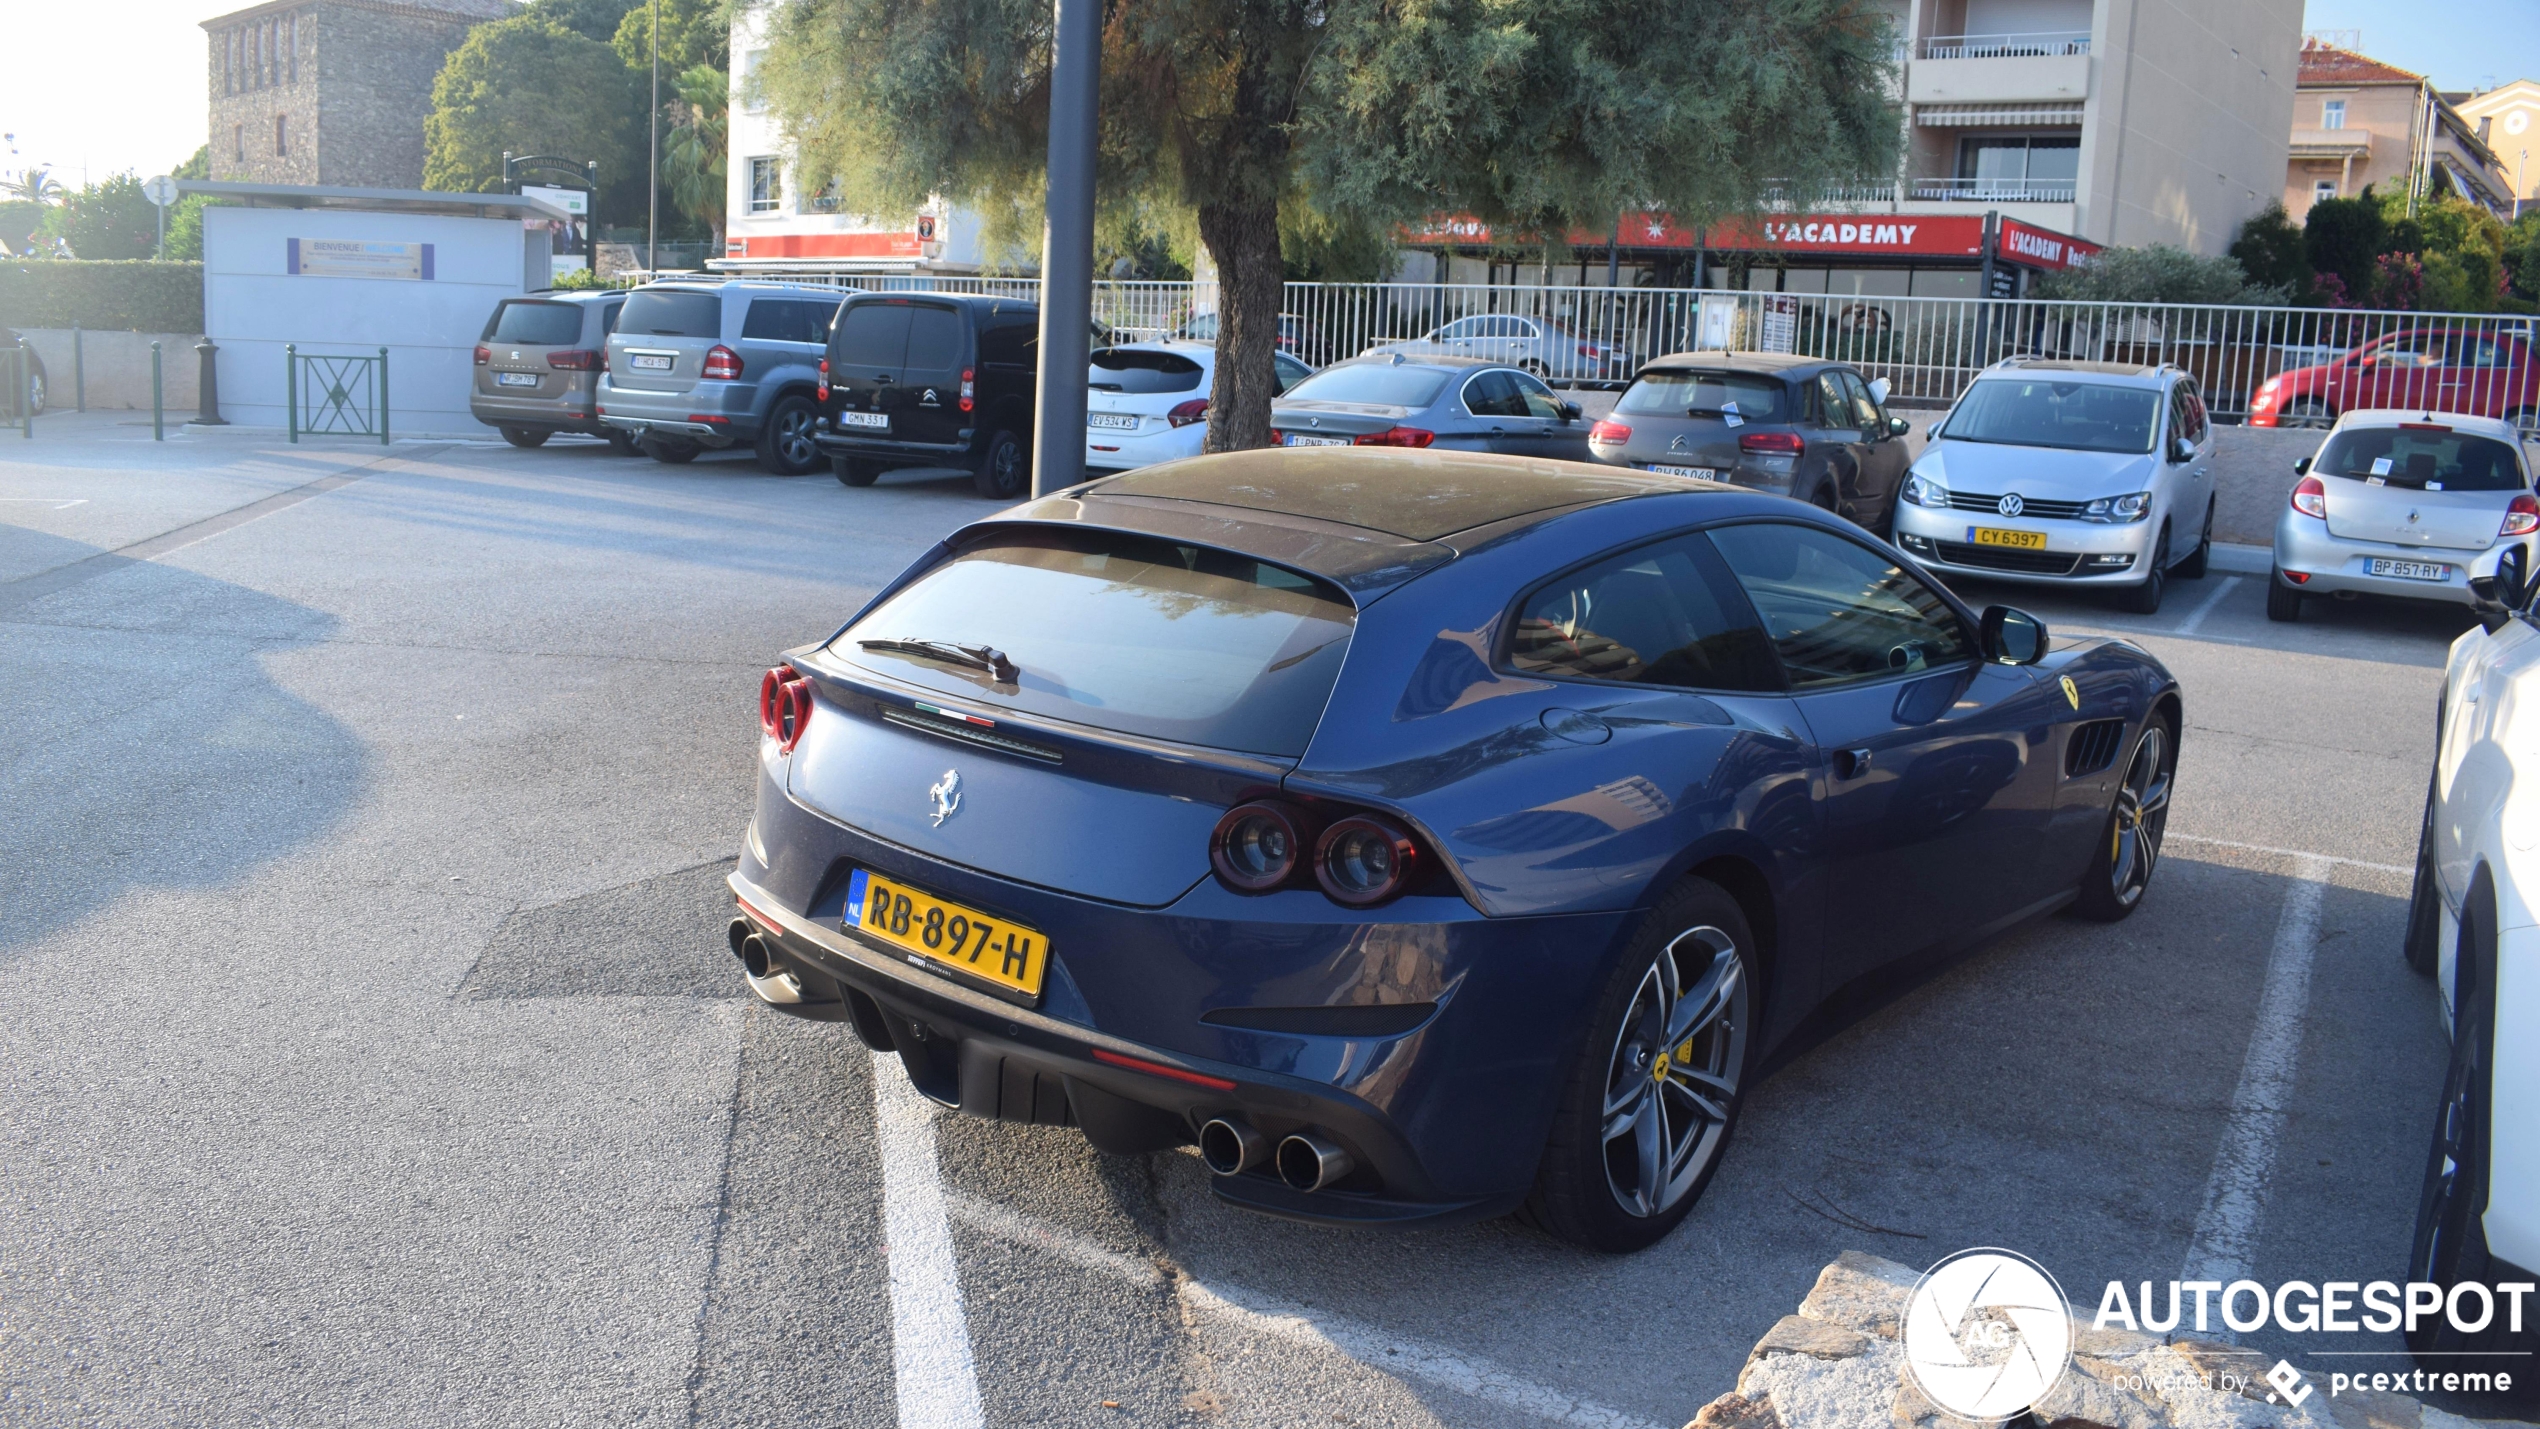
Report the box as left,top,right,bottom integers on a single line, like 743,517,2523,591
2403,893,2540,1399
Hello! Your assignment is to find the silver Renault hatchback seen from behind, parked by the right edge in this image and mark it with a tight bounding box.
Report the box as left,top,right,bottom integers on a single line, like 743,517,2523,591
2266,409,2540,619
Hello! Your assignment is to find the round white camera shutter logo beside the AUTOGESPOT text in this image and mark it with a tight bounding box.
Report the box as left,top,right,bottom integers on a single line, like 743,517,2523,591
1905,1249,2073,1419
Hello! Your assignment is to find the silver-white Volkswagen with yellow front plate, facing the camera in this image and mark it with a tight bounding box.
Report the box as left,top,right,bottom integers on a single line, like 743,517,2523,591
1895,358,2215,614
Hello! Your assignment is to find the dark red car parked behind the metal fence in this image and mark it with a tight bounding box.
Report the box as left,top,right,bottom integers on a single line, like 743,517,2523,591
2248,327,2540,429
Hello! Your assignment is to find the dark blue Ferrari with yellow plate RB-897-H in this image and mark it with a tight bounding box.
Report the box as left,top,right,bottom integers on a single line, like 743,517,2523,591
732,449,2179,1251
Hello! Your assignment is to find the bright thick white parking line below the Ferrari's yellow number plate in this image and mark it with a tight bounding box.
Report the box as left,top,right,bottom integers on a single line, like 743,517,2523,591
874,1053,983,1429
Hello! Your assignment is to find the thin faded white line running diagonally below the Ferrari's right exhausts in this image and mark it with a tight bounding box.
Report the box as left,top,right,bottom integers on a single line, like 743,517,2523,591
944,1190,1664,1429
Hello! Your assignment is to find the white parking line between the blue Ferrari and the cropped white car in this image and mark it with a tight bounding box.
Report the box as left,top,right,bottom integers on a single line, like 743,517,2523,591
2179,853,2332,1284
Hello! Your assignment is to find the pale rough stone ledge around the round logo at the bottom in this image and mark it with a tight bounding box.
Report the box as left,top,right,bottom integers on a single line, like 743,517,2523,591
1684,1251,2527,1429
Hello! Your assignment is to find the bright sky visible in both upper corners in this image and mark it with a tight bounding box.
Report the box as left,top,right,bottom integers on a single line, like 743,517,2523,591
0,0,2540,188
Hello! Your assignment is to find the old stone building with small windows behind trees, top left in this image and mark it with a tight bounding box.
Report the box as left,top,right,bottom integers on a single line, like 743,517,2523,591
203,0,518,188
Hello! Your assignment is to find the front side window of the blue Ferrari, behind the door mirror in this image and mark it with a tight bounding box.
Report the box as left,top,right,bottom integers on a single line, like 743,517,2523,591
1712,523,1971,690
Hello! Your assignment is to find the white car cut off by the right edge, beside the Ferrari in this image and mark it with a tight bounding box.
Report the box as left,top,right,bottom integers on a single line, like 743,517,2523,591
2405,558,2540,1383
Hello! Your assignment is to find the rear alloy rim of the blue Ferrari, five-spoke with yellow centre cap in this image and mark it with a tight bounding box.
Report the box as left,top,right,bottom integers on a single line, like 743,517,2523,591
1603,924,1750,1218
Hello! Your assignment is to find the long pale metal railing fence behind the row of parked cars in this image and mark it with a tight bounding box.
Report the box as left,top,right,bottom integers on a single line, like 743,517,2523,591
726,274,2540,431
